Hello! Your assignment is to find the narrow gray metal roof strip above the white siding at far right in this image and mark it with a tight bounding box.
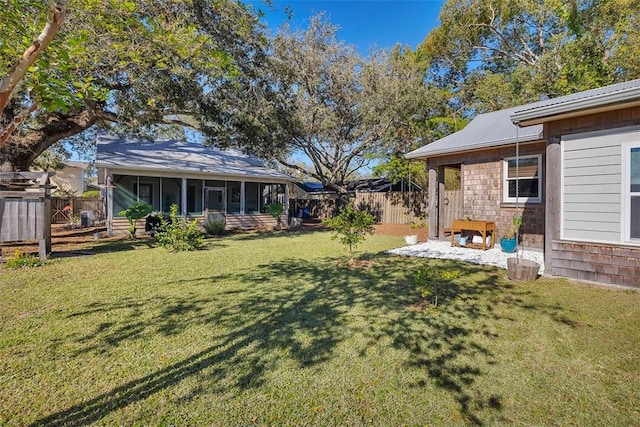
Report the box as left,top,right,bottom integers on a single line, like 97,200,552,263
511,79,640,123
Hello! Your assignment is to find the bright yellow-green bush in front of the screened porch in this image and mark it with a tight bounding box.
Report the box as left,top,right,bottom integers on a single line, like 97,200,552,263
156,204,204,252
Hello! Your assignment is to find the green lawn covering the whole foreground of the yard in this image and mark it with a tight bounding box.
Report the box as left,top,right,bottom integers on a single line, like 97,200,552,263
0,232,640,426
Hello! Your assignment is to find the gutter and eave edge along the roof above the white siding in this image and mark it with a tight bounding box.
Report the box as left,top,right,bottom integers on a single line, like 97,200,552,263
511,87,640,127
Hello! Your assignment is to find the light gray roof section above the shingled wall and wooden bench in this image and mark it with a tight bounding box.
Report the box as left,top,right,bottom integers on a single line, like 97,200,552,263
405,107,542,159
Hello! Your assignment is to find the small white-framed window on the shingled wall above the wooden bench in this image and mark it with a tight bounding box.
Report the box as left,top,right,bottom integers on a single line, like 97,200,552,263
503,154,542,203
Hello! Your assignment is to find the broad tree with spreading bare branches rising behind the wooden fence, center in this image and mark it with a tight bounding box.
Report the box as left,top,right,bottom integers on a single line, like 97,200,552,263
202,15,442,194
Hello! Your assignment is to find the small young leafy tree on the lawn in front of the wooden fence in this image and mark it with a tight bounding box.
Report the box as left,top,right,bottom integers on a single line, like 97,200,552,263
322,203,375,259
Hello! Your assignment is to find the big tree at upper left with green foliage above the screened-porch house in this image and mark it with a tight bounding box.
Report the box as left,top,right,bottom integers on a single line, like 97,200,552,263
0,0,266,171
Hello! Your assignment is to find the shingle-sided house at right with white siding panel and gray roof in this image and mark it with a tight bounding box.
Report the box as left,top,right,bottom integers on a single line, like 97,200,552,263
407,80,640,288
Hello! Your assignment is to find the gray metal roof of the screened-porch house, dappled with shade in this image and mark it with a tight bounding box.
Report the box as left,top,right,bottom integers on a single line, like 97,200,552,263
96,133,293,181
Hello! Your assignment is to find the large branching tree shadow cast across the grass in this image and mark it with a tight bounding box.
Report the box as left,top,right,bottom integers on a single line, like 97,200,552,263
32,255,580,426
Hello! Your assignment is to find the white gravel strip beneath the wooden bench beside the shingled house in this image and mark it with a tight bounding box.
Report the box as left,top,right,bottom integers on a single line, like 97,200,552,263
388,240,544,274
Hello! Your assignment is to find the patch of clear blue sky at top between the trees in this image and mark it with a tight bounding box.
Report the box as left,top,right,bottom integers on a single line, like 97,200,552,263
244,0,445,54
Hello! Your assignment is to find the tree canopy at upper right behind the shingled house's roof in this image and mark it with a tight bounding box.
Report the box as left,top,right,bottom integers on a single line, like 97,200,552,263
416,0,640,112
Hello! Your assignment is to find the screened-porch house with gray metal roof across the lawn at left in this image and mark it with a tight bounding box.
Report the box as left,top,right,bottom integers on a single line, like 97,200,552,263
96,134,291,233
